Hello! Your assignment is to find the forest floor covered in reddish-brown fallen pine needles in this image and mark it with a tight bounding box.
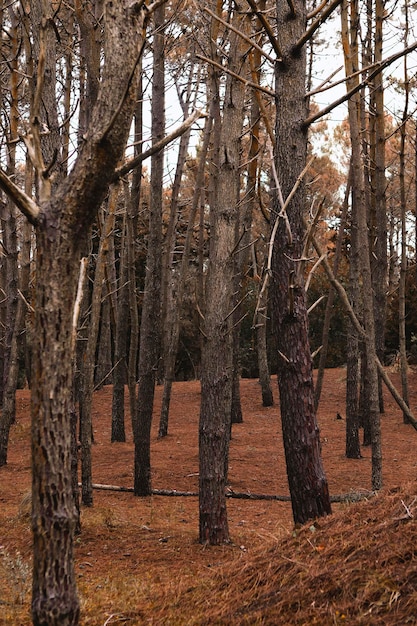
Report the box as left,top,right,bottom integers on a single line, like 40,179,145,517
0,369,417,626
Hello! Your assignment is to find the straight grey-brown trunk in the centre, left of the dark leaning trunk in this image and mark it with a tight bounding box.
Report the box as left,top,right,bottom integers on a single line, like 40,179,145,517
199,6,244,545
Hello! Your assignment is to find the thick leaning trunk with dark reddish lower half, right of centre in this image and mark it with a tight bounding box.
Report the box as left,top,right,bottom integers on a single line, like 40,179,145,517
270,0,331,523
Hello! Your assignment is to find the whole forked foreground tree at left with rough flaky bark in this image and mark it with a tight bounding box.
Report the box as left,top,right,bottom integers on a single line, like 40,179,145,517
0,0,148,626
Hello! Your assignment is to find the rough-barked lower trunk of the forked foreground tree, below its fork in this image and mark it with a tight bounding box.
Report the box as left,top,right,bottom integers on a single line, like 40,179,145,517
32,222,80,626
